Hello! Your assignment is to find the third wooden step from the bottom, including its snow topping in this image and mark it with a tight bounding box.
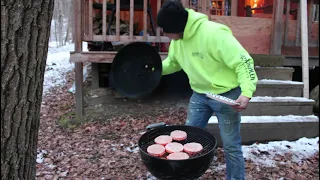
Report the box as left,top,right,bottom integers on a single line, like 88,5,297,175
254,79,303,97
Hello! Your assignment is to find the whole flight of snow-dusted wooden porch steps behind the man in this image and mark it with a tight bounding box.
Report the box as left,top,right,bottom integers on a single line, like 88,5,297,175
207,56,319,146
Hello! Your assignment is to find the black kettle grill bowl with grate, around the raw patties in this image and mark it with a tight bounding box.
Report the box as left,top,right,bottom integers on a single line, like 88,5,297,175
138,125,217,180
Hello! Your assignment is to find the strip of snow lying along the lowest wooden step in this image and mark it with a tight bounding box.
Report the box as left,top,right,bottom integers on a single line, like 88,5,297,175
208,115,319,124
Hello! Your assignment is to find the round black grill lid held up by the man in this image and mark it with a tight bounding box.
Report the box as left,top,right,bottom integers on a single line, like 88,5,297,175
109,42,162,98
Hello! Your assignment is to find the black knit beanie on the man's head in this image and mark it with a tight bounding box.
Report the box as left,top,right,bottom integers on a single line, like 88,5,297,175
157,0,188,33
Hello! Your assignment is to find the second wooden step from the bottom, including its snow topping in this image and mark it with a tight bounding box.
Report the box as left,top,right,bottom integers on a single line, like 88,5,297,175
242,96,315,116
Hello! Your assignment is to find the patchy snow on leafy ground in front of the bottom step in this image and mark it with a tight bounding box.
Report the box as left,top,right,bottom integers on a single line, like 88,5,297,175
242,137,319,167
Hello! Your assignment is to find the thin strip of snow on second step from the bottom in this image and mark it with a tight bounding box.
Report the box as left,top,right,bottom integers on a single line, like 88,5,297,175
250,96,315,102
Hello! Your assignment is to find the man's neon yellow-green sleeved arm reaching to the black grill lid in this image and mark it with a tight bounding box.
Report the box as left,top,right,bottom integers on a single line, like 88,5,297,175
162,46,181,75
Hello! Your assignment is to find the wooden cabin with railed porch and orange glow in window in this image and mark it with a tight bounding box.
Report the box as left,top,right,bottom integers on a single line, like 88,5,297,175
70,0,319,117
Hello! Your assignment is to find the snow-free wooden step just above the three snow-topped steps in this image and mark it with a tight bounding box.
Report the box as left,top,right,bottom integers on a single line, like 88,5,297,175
255,66,294,81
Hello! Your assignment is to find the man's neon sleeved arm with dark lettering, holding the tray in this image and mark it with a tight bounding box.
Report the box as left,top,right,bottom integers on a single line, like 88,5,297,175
212,31,258,98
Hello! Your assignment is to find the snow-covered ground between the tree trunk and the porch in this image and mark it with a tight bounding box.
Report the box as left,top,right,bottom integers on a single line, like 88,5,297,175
43,42,88,94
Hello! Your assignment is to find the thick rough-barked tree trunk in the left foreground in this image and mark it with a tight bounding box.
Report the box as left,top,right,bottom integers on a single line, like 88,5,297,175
1,0,54,179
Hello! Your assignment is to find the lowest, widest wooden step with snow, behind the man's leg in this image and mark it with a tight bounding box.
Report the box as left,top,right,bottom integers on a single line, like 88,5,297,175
207,115,319,146
